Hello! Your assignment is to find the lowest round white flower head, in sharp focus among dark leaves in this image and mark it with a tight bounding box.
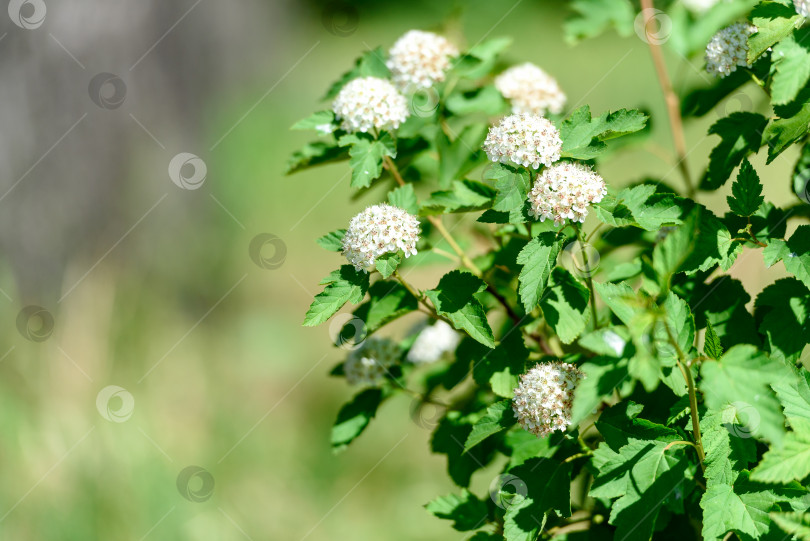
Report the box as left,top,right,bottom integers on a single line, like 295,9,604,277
512,362,585,438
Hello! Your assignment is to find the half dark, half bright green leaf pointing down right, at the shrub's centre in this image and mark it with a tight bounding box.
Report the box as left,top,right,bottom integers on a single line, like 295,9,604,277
425,270,495,348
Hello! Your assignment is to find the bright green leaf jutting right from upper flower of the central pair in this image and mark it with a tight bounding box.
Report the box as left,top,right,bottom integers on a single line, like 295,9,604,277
560,105,649,160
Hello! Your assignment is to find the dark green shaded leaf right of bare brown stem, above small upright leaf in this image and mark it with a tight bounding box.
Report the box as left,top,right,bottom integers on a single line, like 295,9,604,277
701,111,768,190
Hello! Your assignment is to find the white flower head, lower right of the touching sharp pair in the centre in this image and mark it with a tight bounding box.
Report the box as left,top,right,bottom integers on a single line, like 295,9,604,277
529,162,607,225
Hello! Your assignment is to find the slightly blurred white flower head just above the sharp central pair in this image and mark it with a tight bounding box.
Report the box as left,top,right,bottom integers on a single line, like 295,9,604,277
495,62,565,115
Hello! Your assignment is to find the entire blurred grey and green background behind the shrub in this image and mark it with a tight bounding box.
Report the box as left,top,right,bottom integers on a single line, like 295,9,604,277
0,0,796,541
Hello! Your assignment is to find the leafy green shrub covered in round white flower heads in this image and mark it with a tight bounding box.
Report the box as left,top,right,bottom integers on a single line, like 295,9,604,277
288,0,810,541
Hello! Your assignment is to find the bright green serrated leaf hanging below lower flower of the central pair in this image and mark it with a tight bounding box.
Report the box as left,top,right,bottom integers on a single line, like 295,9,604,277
517,232,562,314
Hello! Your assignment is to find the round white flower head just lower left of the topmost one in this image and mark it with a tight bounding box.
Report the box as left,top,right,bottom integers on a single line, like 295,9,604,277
332,77,409,132
